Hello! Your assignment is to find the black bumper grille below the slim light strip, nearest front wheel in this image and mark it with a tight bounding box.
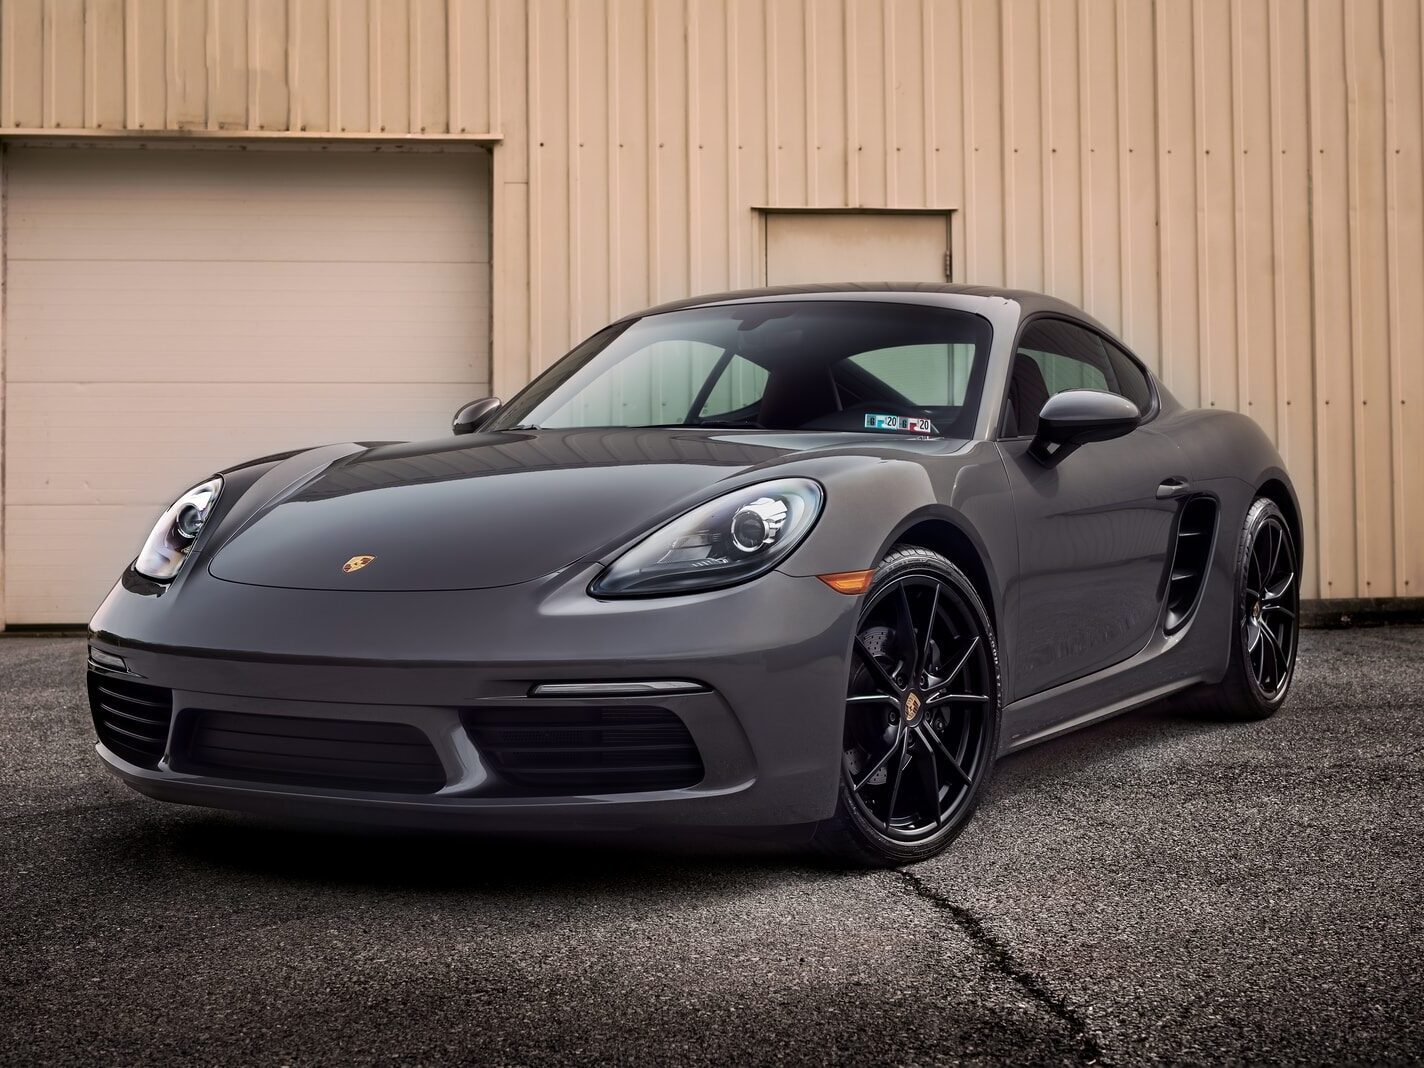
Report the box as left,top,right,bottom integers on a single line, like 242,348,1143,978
464,708,702,795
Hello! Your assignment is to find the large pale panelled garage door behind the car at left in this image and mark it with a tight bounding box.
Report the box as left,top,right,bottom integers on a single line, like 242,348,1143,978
3,147,490,624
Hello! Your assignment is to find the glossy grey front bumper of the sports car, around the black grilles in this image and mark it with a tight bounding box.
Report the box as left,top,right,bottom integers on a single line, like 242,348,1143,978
90,568,859,830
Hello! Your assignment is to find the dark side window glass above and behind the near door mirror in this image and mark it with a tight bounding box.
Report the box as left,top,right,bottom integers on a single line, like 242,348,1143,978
1004,319,1133,437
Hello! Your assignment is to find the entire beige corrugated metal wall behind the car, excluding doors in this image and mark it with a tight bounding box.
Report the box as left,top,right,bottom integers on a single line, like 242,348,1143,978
0,0,1424,609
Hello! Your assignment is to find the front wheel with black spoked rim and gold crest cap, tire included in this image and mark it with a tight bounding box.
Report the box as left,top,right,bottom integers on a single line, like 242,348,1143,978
813,547,1001,867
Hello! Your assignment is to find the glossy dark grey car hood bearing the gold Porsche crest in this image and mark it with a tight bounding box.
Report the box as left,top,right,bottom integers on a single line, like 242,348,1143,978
208,429,864,591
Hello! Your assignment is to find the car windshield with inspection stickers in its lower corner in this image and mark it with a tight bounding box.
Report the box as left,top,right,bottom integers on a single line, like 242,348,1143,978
488,300,991,437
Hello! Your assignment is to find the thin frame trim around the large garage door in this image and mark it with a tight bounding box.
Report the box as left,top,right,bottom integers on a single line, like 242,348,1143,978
0,130,501,632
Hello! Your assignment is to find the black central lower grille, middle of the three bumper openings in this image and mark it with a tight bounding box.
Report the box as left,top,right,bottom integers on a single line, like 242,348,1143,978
177,709,446,793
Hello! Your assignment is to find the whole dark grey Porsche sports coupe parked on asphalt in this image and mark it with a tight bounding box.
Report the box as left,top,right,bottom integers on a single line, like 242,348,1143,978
88,285,1302,864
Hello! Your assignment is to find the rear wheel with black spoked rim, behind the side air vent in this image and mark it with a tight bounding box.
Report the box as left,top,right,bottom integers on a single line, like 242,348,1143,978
1176,497,1300,721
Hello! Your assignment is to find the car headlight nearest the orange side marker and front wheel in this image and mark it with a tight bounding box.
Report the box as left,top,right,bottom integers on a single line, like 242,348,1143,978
588,478,824,597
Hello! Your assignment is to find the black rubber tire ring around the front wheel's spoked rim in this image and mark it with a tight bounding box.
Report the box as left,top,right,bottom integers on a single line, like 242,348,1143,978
836,550,1002,864
